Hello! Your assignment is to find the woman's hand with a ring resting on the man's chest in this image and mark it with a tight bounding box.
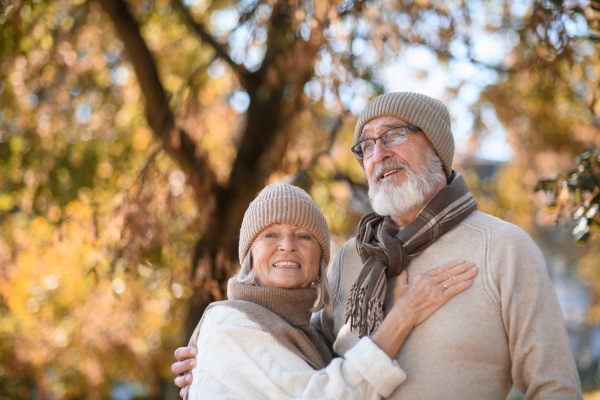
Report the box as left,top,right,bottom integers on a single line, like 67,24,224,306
393,260,477,326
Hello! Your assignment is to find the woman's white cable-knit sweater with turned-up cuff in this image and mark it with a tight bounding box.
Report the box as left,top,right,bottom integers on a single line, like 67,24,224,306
188,306,405,400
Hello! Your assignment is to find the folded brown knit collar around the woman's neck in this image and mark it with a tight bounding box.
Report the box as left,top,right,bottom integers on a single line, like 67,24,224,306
227,278,317,326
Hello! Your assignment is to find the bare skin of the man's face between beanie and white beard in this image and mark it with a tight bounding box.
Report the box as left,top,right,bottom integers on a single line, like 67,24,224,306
361,116,430,187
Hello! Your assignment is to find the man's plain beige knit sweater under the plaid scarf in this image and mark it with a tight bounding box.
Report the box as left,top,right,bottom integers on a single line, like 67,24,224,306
313,211,581,400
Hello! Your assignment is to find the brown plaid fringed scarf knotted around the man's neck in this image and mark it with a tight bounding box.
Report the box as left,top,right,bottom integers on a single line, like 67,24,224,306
346,171,477,337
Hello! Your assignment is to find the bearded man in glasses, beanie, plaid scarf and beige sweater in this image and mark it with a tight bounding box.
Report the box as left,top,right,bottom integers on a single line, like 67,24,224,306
173,93,581,400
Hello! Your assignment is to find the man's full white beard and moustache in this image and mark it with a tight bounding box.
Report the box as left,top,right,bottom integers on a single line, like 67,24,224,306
369,148,446,216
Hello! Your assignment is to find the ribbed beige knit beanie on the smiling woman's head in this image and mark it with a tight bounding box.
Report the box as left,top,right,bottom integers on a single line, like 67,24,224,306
239,182,330,263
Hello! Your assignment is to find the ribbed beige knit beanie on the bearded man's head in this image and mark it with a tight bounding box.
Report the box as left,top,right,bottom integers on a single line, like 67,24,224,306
354,92,454,179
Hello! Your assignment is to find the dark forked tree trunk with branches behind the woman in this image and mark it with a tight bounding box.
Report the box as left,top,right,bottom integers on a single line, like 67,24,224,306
101,0,325,344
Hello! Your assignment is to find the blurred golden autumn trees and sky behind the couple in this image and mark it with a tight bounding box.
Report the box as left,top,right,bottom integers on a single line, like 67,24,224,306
0,0,600,400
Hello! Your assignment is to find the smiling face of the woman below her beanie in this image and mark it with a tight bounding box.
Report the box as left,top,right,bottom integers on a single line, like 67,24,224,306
251,223,321,289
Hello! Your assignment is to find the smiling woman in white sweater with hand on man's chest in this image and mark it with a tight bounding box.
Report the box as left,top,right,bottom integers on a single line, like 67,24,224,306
174,183,476,400
